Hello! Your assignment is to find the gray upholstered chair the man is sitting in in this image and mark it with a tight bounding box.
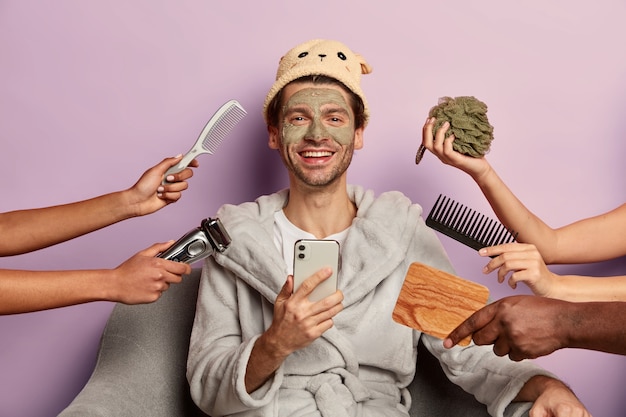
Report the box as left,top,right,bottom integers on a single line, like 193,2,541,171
59,269,528,417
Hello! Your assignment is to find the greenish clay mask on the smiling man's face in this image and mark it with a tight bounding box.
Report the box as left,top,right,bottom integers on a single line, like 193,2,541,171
283,88,354,145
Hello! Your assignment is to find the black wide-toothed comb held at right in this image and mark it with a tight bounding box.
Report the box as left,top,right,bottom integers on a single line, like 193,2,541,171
426,194,517,250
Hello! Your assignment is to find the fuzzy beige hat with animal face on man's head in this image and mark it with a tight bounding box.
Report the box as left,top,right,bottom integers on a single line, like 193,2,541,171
263,39,372,124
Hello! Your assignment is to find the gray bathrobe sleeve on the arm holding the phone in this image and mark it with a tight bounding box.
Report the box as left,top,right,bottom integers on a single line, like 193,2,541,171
187,258,282,415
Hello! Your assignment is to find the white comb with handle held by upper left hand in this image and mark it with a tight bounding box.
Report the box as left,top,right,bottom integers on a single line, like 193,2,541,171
163,100,247,184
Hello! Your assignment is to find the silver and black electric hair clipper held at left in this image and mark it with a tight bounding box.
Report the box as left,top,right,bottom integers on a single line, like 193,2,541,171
157,217,231,264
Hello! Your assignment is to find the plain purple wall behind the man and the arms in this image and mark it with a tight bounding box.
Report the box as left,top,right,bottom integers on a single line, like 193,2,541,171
0,0,626,417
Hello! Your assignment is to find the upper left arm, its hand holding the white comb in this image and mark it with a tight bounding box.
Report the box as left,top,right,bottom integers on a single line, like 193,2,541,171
0,156,198,256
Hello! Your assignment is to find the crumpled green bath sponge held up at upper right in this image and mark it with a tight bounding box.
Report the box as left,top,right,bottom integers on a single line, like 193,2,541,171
428,96,493,158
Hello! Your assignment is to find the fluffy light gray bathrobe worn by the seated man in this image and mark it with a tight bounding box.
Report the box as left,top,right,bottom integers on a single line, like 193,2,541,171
187,186,550,417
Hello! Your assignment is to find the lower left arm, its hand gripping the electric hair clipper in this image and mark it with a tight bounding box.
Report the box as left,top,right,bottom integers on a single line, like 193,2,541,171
0,241,191,314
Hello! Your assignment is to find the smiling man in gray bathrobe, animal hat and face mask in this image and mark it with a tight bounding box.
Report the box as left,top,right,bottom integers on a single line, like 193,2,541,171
187,40,588,417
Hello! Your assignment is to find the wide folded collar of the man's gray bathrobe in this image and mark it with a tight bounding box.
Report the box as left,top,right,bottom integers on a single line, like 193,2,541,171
215,186,450,306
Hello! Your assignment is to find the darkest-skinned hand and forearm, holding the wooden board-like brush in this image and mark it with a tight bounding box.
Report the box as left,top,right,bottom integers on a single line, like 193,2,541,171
444,295,626,361
